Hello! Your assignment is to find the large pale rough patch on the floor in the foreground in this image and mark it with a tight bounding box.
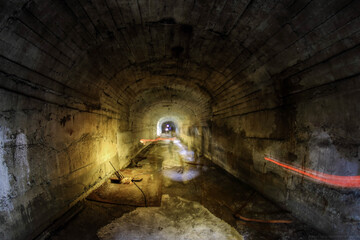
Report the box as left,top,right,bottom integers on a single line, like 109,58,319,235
97,195,243,240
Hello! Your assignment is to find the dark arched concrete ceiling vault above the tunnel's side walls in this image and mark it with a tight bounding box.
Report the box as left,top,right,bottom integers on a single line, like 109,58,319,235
0,0,359,122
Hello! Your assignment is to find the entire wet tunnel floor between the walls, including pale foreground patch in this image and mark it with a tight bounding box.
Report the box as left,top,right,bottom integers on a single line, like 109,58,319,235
49,140,327,240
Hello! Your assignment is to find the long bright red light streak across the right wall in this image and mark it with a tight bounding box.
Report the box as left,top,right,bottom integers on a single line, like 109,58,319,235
264,157,360,188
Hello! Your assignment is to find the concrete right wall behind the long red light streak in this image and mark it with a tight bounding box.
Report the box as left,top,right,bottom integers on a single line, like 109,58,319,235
183,78,360,239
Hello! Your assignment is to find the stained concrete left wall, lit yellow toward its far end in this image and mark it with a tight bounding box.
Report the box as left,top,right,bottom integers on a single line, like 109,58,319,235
0,88,136,240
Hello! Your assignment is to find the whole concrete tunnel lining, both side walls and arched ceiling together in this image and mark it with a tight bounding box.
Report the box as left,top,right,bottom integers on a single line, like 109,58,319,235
0,0,360,239
